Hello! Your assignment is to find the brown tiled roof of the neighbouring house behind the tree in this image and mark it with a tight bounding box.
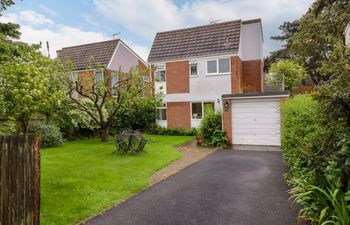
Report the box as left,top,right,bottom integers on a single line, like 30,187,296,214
57,39,120,70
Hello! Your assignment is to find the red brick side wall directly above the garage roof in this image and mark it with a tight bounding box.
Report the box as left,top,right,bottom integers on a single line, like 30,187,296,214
242,60,264,93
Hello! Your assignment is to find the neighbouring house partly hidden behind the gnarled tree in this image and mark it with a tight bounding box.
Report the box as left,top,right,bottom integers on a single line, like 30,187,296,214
57,39,149,93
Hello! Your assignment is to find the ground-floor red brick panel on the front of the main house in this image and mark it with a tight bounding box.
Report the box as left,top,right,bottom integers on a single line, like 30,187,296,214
167,102,191,129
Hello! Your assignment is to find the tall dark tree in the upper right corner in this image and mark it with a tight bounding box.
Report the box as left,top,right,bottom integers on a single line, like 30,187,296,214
270,0,350,84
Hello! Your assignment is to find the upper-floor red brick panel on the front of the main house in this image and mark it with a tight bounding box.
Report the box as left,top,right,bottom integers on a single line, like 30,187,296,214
166,61,190,94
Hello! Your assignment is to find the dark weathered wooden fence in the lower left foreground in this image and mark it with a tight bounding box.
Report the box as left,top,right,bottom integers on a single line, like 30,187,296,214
0,134,40,225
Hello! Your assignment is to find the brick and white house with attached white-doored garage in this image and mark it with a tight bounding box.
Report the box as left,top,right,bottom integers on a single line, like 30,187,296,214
148,19,288,149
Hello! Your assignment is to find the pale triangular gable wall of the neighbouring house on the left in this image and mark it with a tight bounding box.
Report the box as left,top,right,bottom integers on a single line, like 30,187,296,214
108,42,139,73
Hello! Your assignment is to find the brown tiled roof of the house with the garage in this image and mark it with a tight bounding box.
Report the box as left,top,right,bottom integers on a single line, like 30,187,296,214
148,19,261,63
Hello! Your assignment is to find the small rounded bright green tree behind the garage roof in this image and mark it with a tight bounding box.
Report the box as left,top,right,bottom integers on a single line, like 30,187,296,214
270,59,307,91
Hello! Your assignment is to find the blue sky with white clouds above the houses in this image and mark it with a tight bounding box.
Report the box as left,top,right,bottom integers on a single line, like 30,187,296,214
0,0,313,60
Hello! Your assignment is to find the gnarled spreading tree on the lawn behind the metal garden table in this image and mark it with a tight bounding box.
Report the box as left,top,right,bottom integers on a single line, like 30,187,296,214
64,66,150,141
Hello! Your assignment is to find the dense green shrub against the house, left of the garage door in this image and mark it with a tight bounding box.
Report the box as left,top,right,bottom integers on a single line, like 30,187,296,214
200,112,227,147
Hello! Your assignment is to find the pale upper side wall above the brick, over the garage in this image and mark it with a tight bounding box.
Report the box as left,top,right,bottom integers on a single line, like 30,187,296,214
238,22,264,61
